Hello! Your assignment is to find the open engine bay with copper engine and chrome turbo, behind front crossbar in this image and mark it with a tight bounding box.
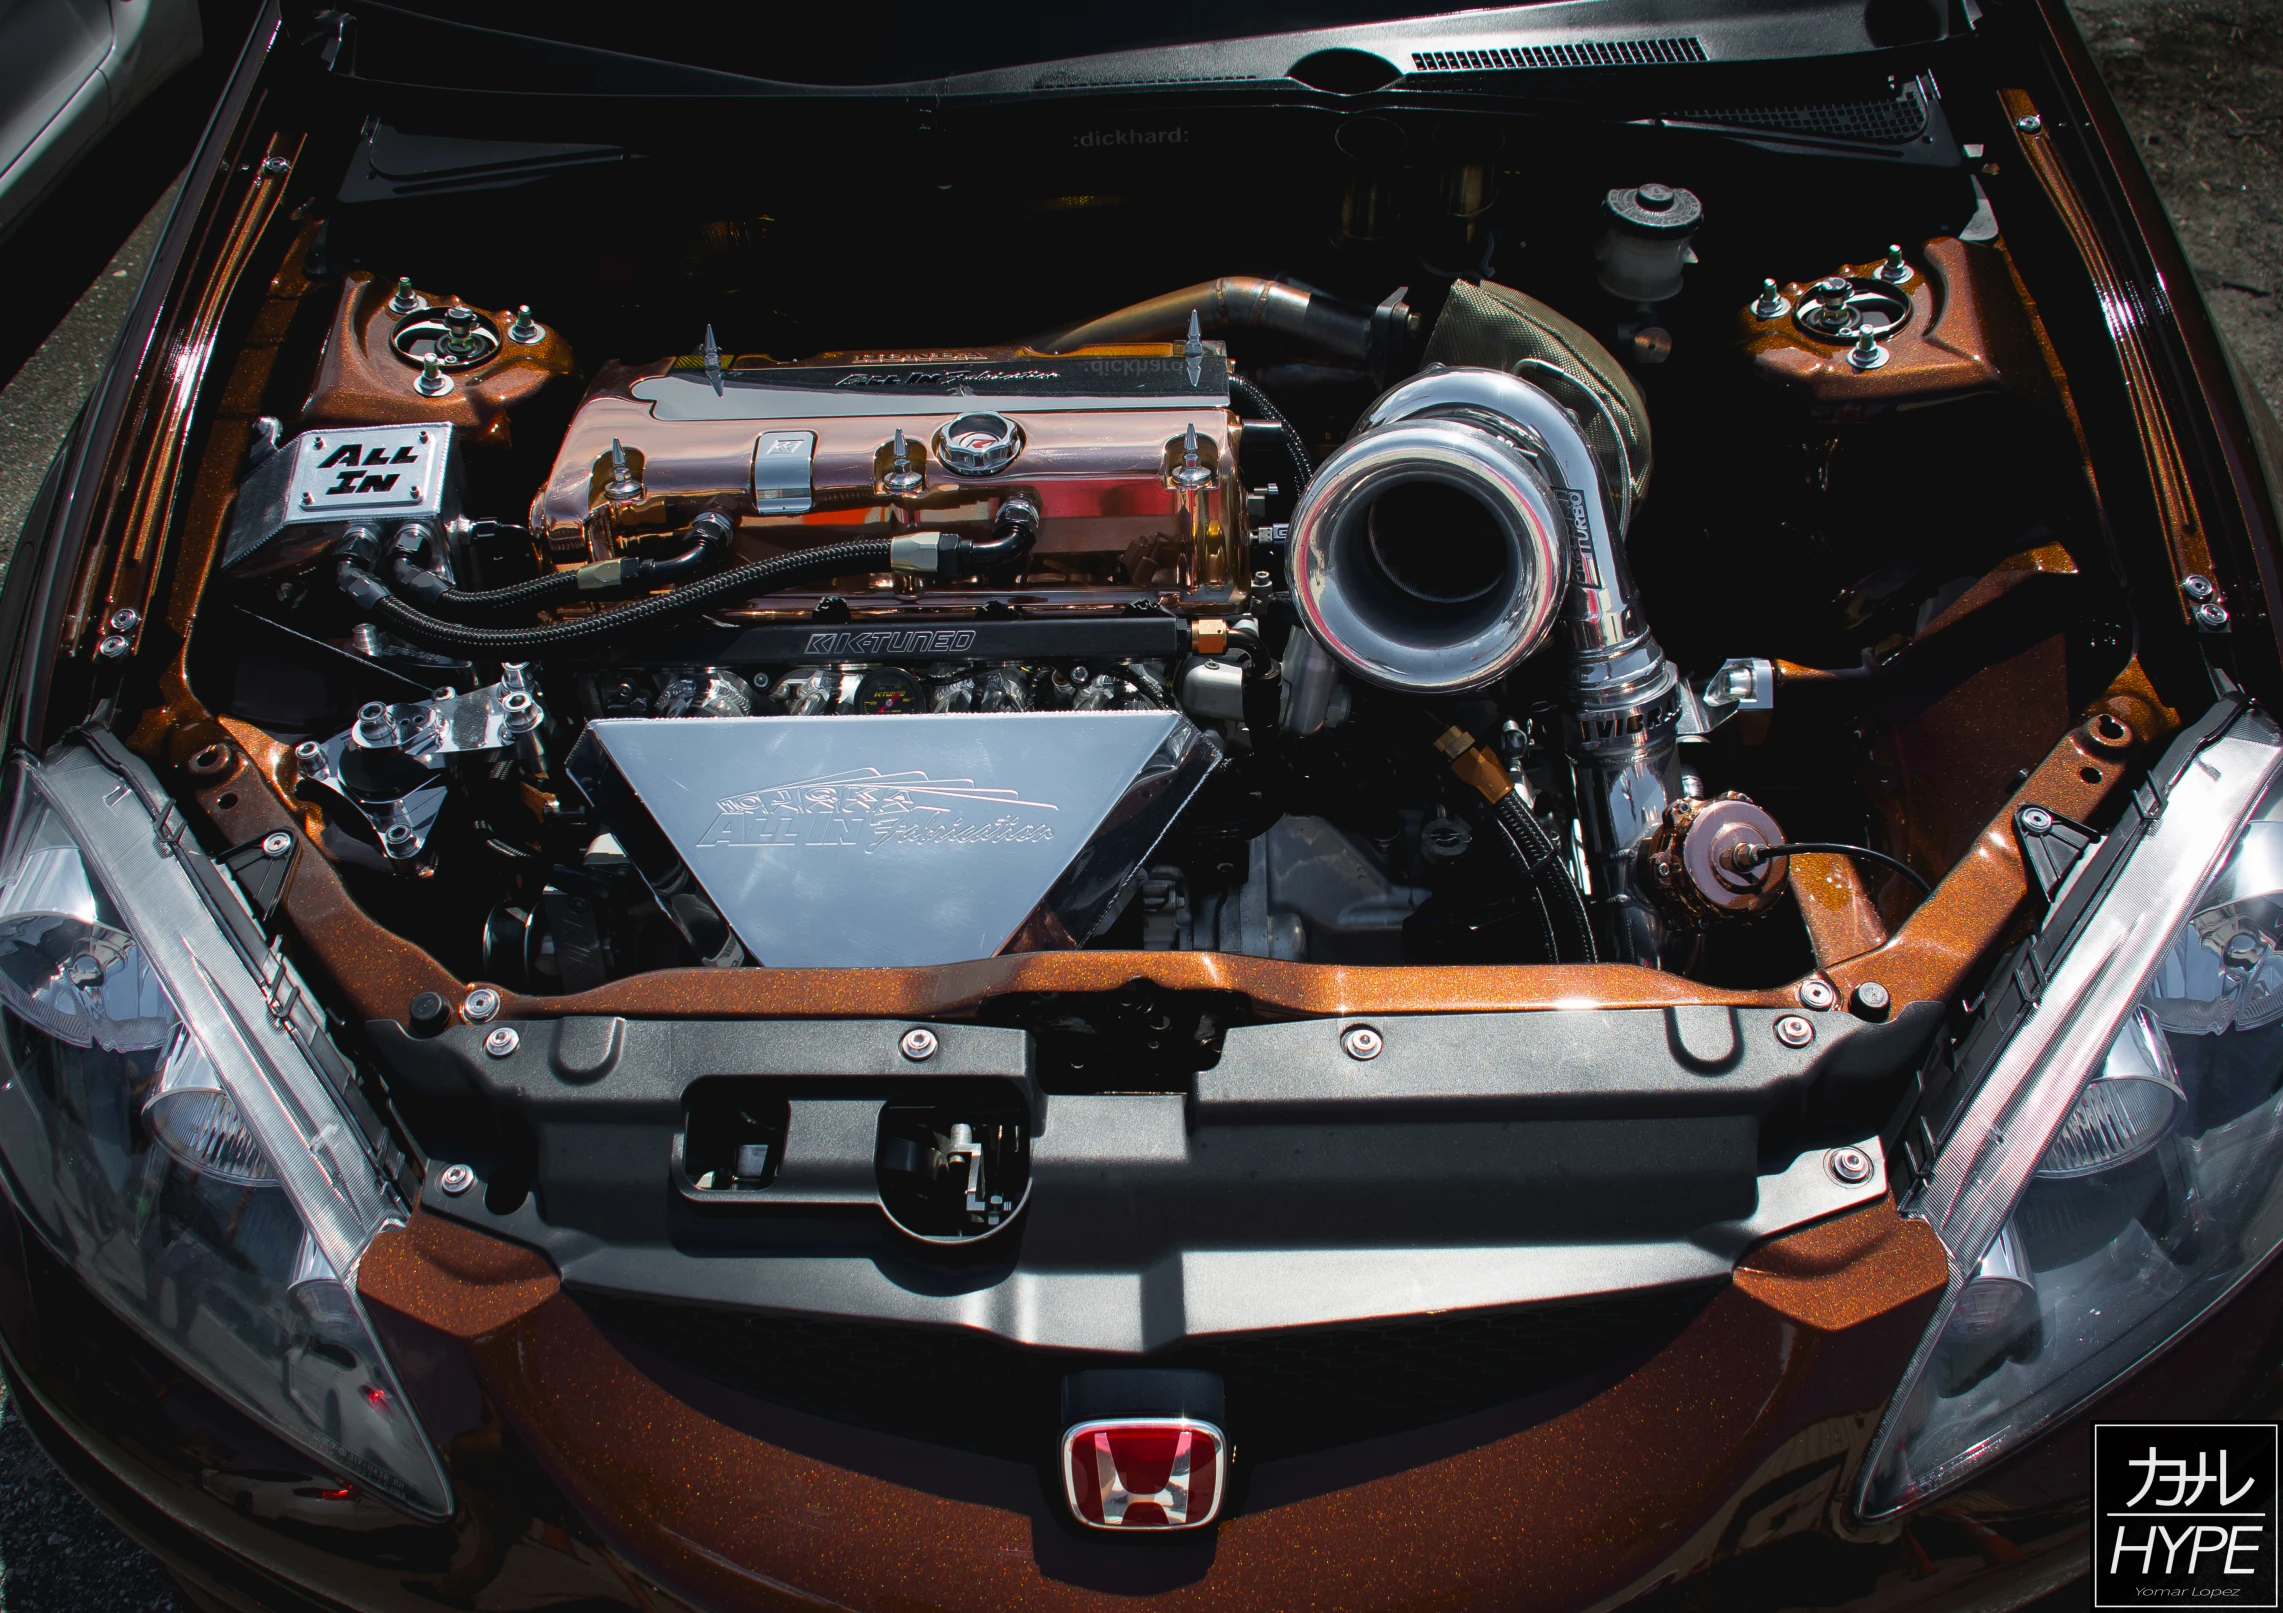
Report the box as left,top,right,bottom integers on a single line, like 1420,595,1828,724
173,113,2128,1026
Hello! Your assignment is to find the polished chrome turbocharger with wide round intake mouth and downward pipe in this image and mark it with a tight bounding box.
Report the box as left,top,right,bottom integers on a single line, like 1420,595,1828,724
1290,367,1680,965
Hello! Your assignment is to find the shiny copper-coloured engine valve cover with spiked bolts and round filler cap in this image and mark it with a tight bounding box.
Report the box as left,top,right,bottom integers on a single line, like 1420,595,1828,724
527,345,1249,616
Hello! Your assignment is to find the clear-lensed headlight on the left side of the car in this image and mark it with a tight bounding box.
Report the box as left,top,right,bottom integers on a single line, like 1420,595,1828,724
0,735,452,1517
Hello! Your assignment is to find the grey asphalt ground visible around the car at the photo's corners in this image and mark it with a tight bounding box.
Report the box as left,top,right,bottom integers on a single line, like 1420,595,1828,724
0,0,2283,1613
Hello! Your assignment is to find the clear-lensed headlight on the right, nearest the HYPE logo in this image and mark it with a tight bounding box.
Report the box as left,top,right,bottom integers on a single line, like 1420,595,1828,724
1858,710,2283,1519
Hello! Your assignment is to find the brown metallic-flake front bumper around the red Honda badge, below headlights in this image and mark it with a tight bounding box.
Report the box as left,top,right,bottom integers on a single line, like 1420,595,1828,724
0,1205,2209,1611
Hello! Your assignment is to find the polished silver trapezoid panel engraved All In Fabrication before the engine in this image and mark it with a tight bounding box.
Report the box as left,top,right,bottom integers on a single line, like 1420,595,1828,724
568,712,1219,967
